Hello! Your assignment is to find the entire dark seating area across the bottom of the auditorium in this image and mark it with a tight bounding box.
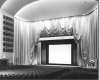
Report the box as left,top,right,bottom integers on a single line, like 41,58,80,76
0,65,98,79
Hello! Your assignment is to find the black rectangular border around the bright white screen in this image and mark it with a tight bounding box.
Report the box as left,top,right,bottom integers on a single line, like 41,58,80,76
46,40,76,66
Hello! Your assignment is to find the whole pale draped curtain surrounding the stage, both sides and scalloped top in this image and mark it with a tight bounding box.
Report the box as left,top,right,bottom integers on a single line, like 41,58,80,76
14,8,99,67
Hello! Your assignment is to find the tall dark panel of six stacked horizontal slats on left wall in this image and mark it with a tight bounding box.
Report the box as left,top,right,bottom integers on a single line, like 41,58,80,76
3,15,14,52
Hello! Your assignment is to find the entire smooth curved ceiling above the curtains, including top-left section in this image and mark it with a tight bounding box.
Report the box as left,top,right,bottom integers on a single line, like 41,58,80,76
0,0,98,21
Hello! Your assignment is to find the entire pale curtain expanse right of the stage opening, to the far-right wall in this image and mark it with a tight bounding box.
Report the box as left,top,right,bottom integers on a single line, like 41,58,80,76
73,8,99,68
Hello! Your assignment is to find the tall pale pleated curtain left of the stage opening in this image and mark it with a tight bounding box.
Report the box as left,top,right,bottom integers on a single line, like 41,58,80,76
14,19,38,65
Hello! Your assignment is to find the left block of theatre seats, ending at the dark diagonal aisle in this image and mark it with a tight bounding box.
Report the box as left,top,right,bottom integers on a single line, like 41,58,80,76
0,66,65,79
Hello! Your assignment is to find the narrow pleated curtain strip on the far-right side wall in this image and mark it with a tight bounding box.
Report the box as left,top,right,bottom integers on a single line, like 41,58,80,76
89,8,99,67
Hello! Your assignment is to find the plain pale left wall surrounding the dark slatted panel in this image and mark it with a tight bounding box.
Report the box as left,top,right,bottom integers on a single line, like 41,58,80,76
0,10,14,64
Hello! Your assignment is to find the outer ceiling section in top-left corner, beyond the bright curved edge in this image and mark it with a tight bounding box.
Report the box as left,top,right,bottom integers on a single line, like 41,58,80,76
0,0,38,16
